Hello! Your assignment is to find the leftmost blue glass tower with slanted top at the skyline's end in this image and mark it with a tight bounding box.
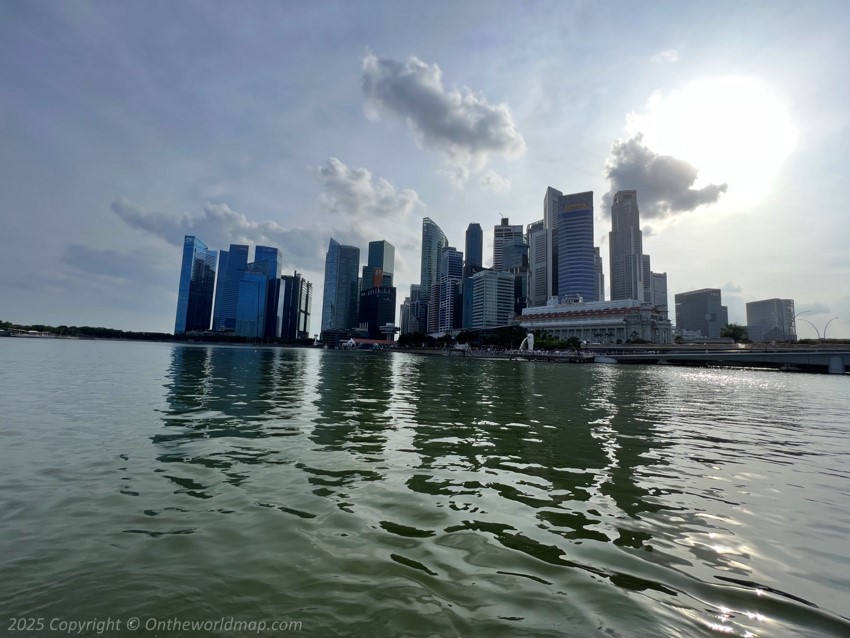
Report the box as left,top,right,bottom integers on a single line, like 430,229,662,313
174,235,218,335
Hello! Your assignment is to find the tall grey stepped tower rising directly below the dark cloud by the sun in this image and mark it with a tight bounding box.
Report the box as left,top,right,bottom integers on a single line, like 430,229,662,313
608,191,644,301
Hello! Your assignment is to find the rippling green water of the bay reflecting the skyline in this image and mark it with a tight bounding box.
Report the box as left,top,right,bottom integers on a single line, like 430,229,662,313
0,339,850,637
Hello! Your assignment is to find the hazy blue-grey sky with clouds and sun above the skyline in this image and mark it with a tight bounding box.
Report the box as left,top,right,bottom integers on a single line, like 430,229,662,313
0,0,850,338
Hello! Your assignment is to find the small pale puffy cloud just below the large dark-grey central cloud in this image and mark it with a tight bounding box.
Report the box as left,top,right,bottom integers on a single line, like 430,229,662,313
315,157,422,219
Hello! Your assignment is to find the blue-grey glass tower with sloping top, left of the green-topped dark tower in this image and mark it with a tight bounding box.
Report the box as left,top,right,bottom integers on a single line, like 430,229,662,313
322,238,360,332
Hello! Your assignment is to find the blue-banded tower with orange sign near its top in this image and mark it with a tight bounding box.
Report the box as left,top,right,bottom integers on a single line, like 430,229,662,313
557,191,597,302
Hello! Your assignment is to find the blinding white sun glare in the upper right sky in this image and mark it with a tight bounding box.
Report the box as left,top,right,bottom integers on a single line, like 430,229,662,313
628,78,797,205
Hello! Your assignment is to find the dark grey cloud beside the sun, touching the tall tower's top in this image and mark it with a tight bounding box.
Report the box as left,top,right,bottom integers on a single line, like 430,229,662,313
603,133,727,219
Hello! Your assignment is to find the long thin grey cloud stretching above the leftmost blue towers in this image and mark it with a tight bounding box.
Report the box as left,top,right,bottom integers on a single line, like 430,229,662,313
112,197,327,269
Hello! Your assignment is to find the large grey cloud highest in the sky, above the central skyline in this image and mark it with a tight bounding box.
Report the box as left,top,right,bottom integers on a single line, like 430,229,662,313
362,53,525,179
